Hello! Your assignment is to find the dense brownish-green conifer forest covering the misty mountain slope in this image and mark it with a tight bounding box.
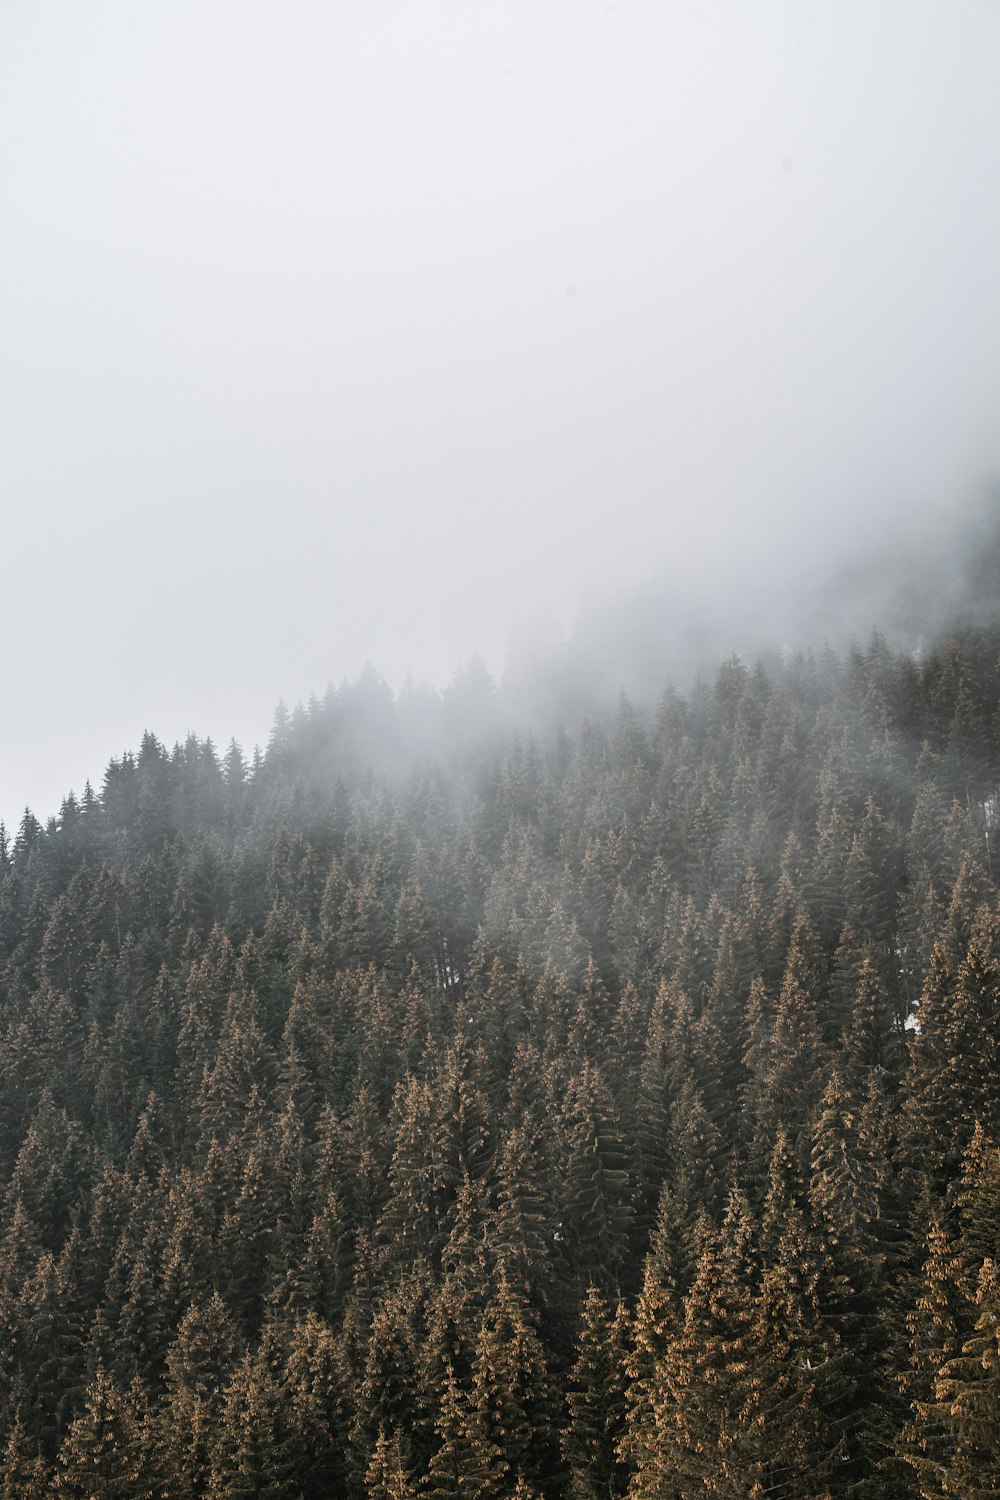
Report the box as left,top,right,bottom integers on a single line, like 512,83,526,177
0,594,1000,1500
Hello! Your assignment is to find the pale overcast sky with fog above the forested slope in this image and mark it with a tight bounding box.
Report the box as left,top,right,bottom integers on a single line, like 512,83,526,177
0,0,1000,821
